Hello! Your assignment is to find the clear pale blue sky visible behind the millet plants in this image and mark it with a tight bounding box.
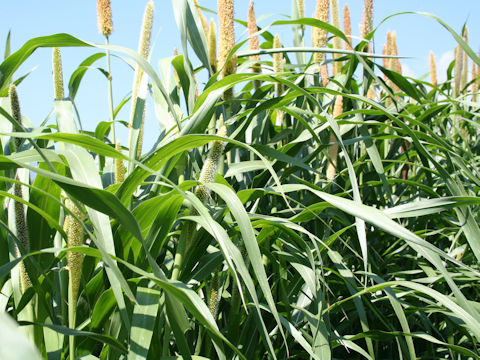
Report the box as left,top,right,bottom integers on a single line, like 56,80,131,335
0,0,480,150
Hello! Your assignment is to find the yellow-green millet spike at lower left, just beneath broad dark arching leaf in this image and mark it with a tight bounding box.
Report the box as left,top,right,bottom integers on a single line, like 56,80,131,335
63,198,84,308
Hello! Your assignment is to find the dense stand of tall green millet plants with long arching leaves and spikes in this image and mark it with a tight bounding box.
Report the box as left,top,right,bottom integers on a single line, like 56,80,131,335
0,0,480,359
